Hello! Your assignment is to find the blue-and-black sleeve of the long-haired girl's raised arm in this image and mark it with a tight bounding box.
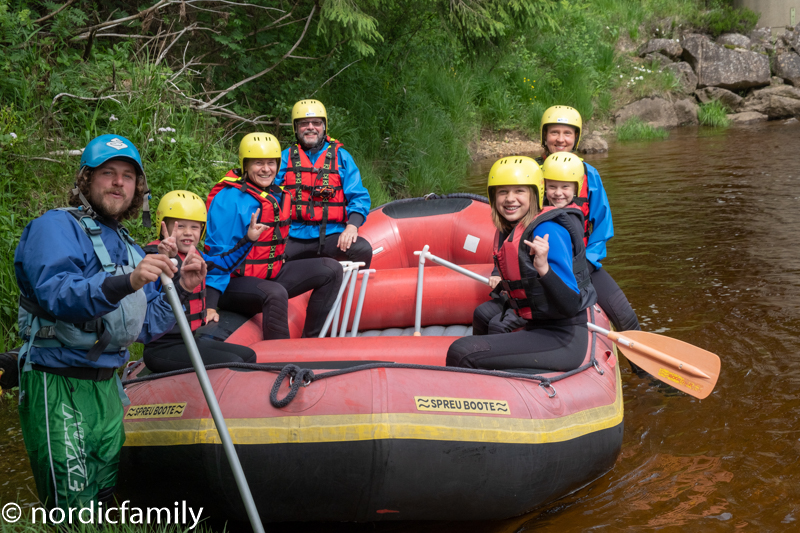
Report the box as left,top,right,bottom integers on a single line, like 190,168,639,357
533,222,581,316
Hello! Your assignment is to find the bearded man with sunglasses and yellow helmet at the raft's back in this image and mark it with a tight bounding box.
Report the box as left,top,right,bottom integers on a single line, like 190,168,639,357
275,100,372,268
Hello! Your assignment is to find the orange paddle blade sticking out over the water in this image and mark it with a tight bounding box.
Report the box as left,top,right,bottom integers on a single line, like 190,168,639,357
609,330,720,399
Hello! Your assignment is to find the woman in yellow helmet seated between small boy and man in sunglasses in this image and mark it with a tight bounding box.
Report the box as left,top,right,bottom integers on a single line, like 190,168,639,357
206,133,342,340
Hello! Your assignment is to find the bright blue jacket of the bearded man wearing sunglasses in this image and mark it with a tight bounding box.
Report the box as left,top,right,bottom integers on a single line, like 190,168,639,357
275,141,372,239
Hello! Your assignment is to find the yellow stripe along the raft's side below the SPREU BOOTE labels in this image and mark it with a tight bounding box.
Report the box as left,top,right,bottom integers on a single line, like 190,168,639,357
125,369,623,446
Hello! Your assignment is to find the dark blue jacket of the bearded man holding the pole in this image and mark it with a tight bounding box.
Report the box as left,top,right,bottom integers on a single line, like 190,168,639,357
14,210,175,368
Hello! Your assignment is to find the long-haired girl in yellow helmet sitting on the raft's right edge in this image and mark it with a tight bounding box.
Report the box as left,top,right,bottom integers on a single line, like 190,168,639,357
447,156,596,371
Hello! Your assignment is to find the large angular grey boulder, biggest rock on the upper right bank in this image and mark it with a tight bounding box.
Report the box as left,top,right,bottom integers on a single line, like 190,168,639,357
682,33,770,90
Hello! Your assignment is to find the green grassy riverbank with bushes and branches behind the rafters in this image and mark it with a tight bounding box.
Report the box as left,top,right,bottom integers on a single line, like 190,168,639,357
0,0,746,350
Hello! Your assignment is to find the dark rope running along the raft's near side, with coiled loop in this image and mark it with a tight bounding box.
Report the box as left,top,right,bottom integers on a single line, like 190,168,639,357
122,309,604,409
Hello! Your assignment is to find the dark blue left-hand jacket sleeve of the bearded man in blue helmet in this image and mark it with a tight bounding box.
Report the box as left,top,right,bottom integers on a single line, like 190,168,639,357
14,211,119,323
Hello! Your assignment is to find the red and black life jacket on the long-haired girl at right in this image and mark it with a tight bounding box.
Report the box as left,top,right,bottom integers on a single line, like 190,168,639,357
494,203,597,321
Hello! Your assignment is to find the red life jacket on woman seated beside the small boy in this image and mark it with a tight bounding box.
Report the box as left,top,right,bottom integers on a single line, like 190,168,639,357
206,169,291,279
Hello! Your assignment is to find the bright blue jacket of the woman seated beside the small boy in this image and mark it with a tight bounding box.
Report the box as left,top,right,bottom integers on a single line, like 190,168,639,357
203,182,280,293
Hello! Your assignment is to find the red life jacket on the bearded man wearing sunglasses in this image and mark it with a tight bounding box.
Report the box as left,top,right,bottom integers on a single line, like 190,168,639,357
283,137,347,240
